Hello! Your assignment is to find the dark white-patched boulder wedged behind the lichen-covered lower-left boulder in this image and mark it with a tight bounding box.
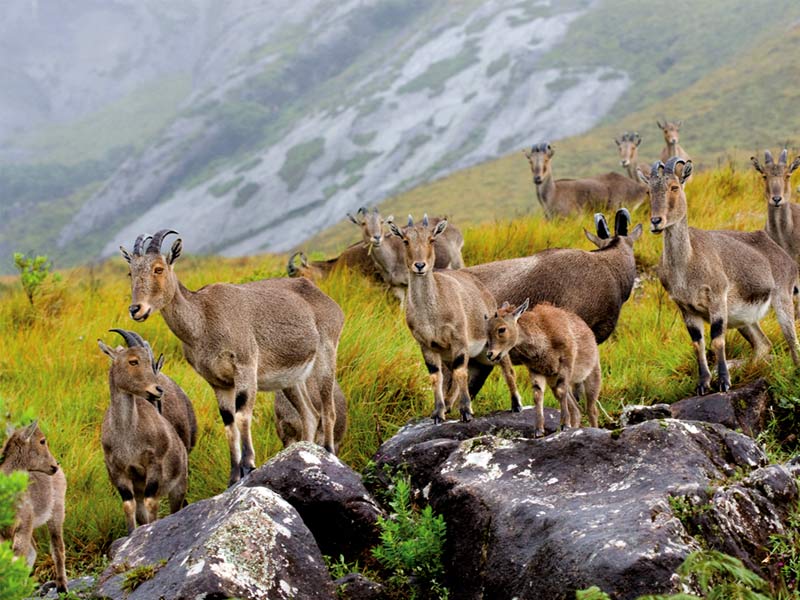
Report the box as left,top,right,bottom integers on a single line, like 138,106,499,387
242,442,384,561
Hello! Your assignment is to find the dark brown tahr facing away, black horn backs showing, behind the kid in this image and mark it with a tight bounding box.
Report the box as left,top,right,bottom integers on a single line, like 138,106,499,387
462,208,642,396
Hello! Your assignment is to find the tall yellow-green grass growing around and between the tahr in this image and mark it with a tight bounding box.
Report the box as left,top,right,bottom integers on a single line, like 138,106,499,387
0,163,800,576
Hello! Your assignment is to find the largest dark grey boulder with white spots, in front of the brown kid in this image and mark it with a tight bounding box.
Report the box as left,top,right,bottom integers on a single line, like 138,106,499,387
382,419,796,600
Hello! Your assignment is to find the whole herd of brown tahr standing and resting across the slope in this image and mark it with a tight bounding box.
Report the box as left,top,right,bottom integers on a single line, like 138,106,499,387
0,122,800,591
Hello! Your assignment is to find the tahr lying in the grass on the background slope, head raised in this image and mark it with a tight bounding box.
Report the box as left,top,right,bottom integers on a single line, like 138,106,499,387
523,142,647,219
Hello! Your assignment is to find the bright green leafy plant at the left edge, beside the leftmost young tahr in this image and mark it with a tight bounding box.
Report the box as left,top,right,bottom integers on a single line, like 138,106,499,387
0,474,33,600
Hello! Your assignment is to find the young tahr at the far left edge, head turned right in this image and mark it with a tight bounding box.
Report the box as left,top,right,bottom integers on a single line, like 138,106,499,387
0,421,67,593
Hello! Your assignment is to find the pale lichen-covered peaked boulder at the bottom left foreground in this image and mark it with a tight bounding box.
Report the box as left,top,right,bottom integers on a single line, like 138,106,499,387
96,486,334,600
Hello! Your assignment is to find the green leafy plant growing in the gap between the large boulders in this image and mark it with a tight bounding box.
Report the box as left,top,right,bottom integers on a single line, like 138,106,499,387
372,478,449,599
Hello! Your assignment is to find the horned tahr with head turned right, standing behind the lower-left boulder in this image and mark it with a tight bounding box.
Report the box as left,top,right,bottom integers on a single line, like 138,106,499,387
97,330,189,535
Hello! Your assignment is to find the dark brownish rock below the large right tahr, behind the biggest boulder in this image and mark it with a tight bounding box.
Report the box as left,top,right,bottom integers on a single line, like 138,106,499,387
670,379,769,437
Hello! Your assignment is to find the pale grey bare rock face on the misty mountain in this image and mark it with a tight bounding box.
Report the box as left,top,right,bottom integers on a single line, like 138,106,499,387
47,0,629,255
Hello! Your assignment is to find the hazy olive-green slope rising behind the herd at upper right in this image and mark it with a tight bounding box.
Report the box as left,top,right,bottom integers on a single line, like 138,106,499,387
310,19,800,253
